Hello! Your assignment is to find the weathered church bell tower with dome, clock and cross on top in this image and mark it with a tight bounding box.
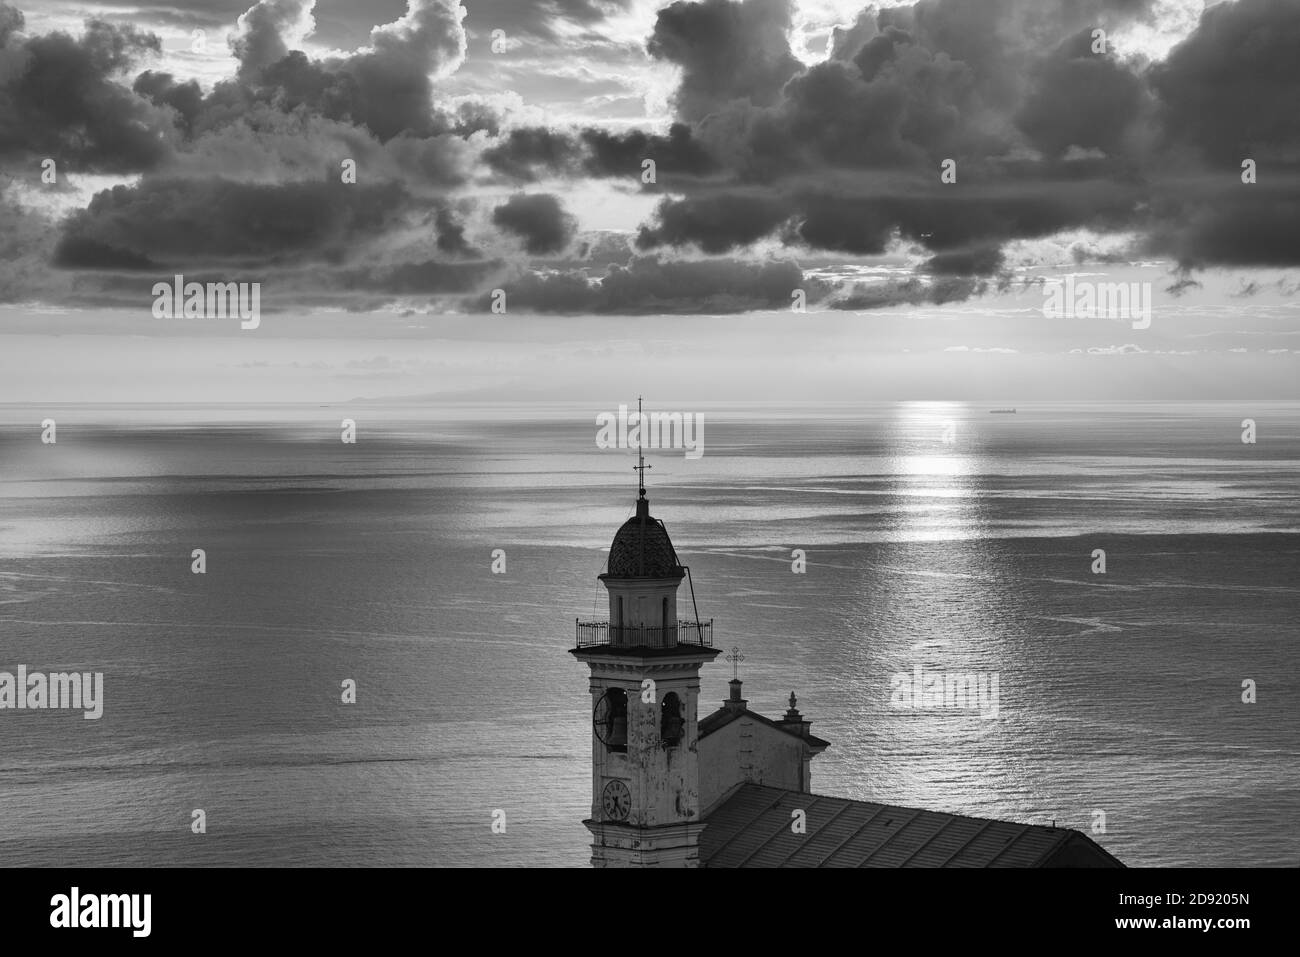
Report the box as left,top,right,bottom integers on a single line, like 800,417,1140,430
571,413,719,867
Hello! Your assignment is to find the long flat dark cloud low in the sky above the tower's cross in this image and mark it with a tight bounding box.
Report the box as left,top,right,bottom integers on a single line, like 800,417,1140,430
483,256,824,315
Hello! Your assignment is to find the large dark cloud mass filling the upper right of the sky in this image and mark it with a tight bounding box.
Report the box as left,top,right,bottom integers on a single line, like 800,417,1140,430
621,0,1300,276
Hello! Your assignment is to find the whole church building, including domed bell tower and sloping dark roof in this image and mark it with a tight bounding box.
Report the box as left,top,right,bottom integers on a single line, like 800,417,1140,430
571,485,1123,867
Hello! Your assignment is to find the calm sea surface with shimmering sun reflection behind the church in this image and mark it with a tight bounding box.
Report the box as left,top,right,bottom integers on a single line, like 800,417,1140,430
0,403,1300,866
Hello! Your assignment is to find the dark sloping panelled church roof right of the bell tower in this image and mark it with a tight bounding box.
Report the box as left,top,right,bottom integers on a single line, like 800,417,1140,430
699,784,1123,867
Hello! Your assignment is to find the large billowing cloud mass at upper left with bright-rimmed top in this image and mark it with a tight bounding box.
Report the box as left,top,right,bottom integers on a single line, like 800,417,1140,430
11,0,506,306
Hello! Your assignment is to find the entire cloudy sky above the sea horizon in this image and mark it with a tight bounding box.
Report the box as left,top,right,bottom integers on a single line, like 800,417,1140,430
0,0,1300,404
